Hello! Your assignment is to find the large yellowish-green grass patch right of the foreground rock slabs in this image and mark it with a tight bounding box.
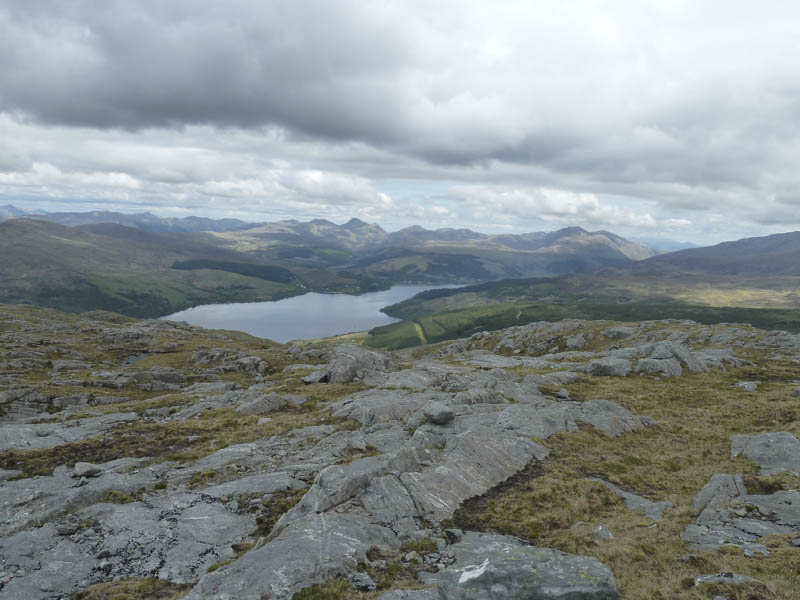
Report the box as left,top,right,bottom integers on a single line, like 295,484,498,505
456,355,800,600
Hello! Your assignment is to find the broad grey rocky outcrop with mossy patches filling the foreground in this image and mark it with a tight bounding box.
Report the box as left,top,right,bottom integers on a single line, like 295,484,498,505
0,309,800,600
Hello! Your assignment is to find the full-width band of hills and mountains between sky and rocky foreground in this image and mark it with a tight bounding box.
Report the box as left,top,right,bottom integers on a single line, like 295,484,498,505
0,205,800,316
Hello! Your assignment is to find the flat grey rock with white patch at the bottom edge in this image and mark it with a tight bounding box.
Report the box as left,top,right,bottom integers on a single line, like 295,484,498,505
423,532,619,600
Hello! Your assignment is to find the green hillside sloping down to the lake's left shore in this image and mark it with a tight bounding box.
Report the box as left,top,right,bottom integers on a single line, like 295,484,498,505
0,221,298,316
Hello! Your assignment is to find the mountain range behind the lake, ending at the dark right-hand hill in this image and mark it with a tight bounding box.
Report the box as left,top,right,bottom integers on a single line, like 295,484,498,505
0,205,656,316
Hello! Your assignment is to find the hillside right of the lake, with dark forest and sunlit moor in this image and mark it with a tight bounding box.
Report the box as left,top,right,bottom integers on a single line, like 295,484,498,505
367,232,800,347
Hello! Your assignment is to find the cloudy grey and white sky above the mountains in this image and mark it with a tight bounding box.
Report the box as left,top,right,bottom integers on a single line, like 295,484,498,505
0,0,800,244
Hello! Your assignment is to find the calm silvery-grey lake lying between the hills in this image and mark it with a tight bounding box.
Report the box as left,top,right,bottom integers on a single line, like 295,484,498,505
162,285,455,342
